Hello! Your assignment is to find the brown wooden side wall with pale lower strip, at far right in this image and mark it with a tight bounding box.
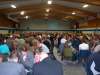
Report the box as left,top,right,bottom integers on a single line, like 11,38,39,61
79,19,100,33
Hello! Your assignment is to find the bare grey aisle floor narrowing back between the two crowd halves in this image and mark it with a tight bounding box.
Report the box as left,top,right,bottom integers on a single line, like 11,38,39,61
54,48,86,75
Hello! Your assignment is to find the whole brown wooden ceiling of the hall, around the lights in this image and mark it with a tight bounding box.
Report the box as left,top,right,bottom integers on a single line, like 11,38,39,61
0,0,100,22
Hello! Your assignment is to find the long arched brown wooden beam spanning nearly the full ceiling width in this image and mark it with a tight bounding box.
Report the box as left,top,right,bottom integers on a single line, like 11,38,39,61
0,4,96,16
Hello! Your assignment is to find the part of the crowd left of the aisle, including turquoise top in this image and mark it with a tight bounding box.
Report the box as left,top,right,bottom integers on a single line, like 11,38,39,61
0,33,63,75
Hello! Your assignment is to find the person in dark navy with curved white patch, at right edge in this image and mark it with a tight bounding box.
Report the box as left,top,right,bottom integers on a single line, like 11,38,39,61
85,45,100,75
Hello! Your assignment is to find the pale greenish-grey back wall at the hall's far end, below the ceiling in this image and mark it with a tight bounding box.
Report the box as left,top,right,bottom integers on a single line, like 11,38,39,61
21,20,71,30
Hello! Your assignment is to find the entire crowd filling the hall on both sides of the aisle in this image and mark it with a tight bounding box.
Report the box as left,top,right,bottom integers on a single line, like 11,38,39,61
0,32,100,75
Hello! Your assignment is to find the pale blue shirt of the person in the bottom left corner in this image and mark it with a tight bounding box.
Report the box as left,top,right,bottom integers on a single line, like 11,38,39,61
0,62,26,75
